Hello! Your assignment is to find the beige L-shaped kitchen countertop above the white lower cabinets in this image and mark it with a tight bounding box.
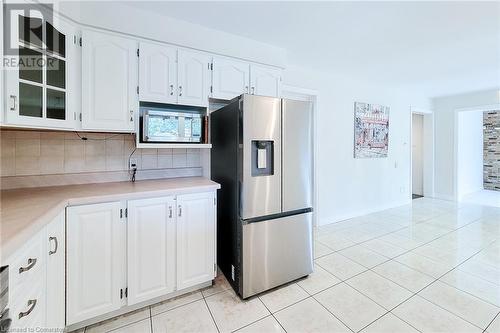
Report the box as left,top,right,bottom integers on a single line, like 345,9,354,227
0,177,220,262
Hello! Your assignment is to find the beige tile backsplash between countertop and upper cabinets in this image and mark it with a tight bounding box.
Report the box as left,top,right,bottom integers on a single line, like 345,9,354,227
0,130,201,177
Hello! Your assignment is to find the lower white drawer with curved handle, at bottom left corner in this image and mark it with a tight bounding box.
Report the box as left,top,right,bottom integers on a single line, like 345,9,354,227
9,287,45,332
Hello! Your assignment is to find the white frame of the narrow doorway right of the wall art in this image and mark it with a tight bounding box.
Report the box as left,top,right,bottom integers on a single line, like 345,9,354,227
409,106,435,200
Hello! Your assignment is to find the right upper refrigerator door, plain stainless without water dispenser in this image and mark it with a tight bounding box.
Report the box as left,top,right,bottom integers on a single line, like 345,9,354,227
282,99,313,212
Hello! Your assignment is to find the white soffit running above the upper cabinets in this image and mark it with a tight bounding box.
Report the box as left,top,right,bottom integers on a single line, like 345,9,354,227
56,1,286,67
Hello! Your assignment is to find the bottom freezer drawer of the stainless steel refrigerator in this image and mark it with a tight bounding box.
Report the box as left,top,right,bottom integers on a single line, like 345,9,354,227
241,213,313,298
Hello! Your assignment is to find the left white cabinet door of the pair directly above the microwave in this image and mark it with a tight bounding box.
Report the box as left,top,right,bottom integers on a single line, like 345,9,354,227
139,42,177,103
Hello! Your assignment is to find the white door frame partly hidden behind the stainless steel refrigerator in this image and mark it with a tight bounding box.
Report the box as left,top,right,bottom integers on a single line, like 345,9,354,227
281,84,319,227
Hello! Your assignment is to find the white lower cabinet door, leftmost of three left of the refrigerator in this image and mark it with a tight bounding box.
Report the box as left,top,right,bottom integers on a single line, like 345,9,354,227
66,202,125,325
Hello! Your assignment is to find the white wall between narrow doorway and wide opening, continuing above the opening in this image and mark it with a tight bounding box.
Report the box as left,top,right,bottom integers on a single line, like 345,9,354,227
432,88,500,200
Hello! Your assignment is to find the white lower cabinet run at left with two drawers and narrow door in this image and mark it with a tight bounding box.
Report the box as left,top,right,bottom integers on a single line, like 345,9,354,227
7,212,65,332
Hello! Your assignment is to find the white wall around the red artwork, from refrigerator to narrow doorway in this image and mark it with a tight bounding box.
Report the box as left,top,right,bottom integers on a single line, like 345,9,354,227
284,66,428,225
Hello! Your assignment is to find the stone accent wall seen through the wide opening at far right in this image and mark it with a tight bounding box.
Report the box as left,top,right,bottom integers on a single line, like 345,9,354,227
483,111,500,191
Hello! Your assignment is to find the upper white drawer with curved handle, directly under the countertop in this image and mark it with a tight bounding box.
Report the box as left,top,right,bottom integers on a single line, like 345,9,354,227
9,232,46,299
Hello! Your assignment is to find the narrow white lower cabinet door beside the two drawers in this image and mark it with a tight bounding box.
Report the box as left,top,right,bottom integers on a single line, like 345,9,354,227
45,212,66,330
